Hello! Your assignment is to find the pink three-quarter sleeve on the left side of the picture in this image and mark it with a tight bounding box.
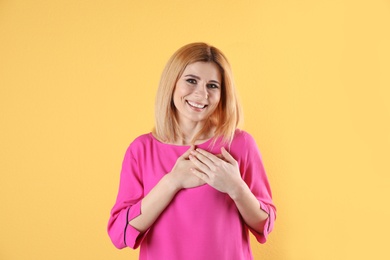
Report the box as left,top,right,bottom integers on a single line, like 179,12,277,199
107,147,147,249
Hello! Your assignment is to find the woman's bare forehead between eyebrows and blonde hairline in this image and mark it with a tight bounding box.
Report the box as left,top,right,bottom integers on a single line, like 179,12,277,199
182,61,221,81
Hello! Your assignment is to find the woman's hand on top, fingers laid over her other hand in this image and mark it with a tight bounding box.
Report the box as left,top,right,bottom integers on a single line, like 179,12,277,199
189,147,244,197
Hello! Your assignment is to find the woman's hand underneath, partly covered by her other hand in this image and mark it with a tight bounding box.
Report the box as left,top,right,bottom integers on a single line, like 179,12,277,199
169,146,205,190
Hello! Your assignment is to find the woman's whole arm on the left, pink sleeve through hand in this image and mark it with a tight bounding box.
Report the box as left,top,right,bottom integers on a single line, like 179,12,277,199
107,147,204,249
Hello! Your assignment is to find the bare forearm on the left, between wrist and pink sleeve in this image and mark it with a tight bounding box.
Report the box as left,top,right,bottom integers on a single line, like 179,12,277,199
129,174,179,232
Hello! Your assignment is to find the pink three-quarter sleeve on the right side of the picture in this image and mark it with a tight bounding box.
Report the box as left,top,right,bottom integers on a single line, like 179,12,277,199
238,133,276,243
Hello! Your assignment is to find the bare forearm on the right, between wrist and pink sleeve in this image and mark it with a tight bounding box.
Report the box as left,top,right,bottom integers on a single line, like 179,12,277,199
229,181,268,233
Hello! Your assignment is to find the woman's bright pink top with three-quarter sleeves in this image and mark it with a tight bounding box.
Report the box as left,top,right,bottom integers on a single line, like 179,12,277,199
108,130,276,260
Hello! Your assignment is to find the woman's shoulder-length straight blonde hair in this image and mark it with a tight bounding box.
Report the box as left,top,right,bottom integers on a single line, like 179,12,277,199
153,42,242,144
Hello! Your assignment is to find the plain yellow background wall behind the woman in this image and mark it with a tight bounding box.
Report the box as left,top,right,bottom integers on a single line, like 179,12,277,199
0,0,390,260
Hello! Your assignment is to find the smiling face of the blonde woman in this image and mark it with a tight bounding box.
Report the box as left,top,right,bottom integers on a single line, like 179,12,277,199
173,62,222,124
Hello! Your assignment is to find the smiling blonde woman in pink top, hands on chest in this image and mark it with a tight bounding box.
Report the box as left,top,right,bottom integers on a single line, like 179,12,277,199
108,43,276,260
